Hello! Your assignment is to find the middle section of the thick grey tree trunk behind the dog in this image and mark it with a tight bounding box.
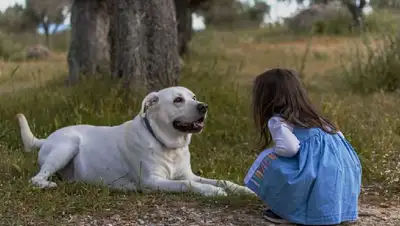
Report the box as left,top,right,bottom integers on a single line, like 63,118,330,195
109,0,147,87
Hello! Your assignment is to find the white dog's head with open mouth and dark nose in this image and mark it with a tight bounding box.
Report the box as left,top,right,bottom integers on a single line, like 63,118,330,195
140,86,208,148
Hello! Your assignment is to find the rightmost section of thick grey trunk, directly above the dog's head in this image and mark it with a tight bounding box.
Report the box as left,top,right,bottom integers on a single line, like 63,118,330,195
142,0,180,91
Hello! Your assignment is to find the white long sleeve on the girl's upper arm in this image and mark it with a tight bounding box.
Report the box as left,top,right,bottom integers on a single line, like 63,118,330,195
268,116,300,157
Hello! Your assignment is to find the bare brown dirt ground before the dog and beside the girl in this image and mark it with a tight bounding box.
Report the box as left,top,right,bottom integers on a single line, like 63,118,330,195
54,187,400,226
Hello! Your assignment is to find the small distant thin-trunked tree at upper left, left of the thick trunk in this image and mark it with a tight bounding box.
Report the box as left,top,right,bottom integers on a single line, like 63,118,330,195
25,0,72,46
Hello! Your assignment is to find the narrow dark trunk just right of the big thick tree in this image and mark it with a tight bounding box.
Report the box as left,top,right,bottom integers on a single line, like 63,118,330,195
174,0,193,56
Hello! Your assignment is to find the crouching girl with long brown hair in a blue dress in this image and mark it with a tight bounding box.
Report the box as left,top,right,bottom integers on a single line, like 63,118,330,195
245,68,361,225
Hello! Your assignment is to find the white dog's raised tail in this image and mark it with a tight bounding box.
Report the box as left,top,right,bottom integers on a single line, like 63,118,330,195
17,114,45,152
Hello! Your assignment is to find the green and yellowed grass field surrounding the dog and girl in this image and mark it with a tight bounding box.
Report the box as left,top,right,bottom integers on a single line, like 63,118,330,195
0,26,400,222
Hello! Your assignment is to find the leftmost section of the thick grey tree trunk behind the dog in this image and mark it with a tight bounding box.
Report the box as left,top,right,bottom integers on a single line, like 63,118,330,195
68,0,109,84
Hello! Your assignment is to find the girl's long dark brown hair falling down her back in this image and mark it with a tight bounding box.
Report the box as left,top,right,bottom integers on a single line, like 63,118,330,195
252,68,338,149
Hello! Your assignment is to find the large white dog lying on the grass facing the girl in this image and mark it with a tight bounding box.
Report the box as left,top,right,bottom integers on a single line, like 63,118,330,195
17,87,254,196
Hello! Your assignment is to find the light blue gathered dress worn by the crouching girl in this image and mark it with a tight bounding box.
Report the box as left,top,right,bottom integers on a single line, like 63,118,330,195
245,127,361,225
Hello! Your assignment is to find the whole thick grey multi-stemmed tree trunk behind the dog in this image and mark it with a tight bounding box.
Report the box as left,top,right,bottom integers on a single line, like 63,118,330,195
68,0,180,90
